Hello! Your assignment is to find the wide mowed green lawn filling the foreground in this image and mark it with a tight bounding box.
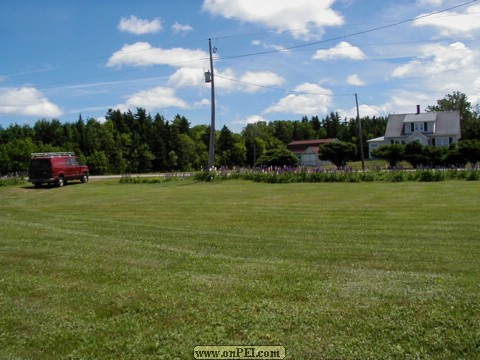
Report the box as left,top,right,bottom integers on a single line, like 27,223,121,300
0,180,480,359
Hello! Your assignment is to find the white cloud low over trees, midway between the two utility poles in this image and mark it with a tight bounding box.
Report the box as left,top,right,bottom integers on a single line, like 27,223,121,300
264,83,333,115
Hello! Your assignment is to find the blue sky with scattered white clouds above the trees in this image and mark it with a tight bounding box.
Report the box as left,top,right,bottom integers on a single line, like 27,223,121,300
0,0,480,132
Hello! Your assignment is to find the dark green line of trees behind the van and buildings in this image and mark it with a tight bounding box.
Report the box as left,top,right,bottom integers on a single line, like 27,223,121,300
0,92,480,175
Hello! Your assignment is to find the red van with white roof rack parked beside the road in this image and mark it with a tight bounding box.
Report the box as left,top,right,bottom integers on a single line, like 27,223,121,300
28,152,89,187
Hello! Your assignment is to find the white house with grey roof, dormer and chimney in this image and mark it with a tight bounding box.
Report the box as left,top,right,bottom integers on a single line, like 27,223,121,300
367,105,461,158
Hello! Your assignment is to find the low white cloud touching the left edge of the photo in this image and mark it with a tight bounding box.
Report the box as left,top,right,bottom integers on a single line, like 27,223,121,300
0,87,63,117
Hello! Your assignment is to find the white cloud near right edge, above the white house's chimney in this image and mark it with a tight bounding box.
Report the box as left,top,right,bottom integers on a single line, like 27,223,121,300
392,42,475,78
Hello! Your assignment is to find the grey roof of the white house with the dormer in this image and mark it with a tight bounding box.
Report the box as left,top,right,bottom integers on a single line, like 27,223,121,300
385,110,460,138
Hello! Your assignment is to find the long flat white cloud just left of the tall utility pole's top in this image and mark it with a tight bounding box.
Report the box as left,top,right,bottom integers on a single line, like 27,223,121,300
107,42,209,68
